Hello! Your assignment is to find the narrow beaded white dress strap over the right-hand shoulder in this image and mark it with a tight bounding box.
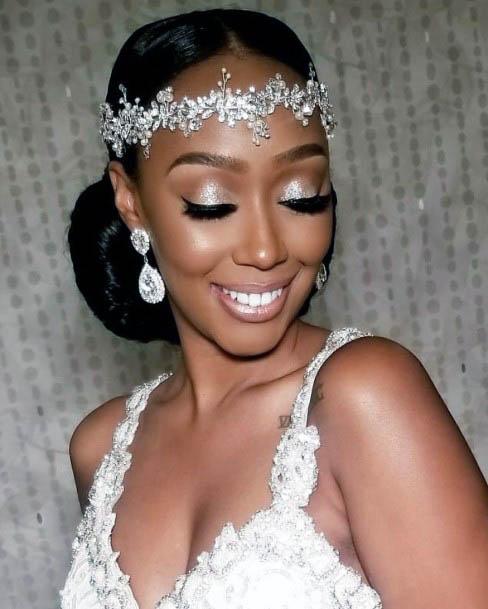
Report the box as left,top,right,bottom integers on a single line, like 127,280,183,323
291,326,374,428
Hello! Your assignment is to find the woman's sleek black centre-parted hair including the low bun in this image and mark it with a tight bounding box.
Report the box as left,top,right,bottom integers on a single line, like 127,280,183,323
68,8,336,345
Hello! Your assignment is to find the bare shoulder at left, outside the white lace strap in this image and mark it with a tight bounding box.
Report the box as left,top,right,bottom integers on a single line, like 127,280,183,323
69,395,128,509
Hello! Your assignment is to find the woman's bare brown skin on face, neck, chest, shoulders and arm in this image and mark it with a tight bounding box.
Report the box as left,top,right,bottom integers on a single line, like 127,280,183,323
70,55,488,609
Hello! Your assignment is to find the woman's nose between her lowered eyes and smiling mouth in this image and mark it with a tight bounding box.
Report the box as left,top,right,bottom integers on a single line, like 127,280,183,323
233,200,288,270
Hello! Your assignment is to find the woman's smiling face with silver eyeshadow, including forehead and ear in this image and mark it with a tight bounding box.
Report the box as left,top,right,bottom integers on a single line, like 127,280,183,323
109,55,333,356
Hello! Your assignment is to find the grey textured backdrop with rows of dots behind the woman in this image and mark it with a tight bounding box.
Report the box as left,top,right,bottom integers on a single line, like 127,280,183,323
0,0,488,609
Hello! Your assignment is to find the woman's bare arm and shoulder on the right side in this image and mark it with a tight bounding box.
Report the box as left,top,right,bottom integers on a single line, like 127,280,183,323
315,337,488,609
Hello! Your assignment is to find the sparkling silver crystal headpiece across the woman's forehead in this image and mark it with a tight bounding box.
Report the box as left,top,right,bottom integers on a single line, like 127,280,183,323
100,62,337,158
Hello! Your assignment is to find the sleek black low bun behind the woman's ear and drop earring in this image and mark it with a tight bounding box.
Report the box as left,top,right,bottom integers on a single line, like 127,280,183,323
68,170,179,344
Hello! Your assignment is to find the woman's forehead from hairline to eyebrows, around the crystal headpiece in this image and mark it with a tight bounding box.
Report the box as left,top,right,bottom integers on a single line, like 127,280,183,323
140,54,328,172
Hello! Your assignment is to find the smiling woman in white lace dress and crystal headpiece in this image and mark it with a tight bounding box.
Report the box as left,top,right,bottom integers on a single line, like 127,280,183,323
61,9,488,609
